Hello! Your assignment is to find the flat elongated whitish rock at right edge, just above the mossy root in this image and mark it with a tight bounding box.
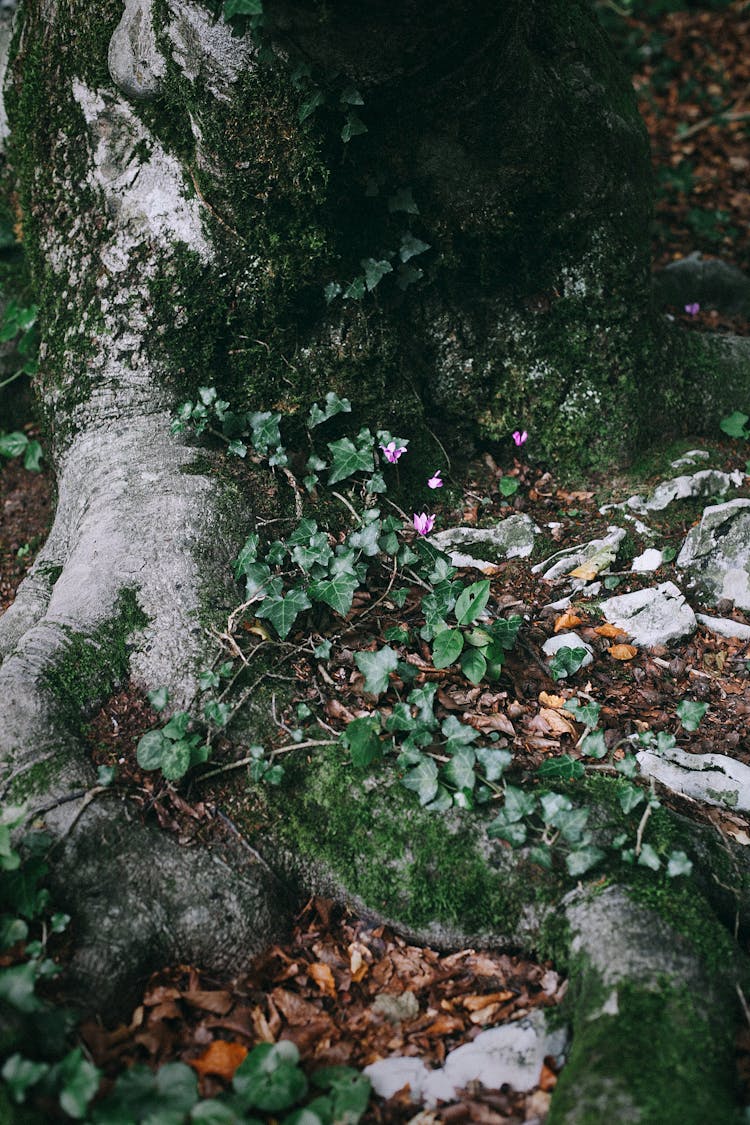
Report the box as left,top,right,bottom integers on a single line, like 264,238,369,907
636,746,750,812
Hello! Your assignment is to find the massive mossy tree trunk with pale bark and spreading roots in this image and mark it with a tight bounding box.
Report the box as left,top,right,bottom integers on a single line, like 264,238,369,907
0,0,750,1123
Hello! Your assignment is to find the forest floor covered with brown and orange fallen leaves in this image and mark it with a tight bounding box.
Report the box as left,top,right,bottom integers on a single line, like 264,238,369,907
0,3,750,1125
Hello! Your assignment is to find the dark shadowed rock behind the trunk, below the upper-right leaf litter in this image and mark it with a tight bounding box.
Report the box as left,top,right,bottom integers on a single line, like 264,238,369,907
653,251,750,316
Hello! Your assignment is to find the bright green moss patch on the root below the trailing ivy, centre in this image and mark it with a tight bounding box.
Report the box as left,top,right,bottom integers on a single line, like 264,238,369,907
249,748,559,935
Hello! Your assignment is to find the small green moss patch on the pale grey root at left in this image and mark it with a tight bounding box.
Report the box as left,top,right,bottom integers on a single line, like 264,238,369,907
45,590,148,731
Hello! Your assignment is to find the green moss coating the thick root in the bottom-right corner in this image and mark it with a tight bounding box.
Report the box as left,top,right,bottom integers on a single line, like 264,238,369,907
549,973,740,1125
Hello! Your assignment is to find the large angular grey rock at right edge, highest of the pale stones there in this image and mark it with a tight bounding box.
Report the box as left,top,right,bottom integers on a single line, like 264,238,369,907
677,500,750,610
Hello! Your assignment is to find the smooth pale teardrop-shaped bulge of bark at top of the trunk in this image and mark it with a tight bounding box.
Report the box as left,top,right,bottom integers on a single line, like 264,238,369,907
107,0,166,101
